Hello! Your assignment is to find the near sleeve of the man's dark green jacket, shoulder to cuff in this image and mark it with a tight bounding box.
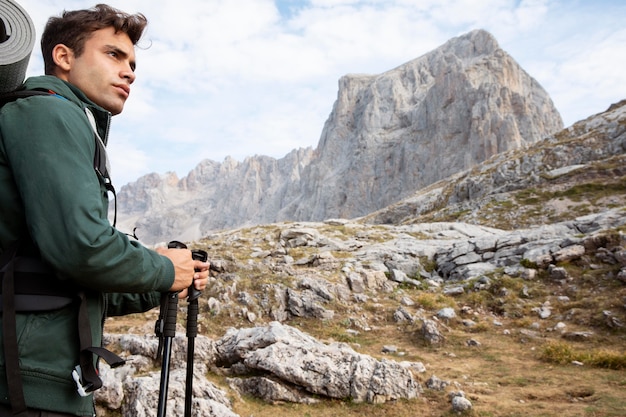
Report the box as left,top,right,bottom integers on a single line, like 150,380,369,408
3,96,174,293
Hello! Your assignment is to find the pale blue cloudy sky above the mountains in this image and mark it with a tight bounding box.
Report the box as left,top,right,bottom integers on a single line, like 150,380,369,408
12,0,626,185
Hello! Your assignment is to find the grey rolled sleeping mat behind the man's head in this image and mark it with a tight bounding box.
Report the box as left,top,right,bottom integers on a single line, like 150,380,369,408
0,0,35,93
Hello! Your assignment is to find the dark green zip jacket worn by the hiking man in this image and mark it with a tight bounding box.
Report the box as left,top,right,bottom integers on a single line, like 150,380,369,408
0,76,174,416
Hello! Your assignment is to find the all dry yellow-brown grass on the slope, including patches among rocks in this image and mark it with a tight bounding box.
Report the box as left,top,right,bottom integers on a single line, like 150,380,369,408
102,214,626,417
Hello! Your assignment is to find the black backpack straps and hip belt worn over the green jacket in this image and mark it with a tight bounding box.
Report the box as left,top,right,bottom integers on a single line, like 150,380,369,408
0,90,125,415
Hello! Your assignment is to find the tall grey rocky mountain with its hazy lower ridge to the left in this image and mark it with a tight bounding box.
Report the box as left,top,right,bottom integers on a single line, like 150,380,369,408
113,30,563,243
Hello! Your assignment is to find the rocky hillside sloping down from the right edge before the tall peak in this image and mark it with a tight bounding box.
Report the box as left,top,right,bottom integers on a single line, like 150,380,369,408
365,100,626,227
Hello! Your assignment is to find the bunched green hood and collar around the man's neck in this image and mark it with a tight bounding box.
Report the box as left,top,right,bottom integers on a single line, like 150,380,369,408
23,75,111,145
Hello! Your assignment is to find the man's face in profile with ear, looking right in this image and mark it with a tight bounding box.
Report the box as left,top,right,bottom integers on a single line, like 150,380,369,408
60,27,135,115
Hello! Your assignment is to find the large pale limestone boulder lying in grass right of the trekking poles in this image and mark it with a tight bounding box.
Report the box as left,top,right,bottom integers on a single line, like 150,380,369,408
216,322,421,403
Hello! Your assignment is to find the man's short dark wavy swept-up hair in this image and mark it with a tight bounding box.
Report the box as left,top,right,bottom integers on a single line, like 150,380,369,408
41,4,148,75
